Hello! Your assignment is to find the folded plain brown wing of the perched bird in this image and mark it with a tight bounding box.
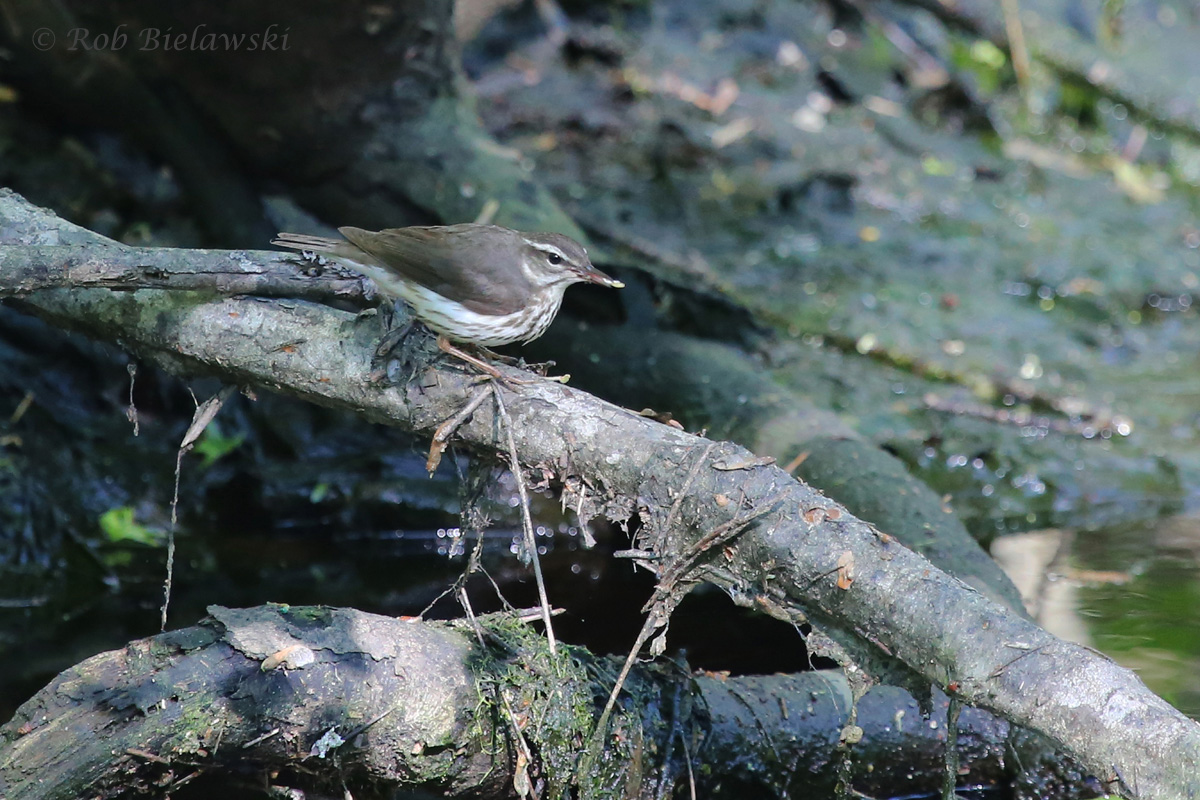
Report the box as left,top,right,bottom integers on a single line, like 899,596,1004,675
338,224,534,317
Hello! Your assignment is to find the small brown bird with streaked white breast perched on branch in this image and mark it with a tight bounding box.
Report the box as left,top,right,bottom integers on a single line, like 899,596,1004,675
271,223,624,377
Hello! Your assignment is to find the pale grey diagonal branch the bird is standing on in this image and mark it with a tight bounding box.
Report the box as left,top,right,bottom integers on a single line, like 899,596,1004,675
0,189,1200,798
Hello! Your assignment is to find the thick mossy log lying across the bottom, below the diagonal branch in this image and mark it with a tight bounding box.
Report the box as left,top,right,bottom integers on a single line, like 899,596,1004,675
0,606,1051,800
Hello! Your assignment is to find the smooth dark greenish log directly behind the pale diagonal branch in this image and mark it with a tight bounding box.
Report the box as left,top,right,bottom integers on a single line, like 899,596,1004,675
527,325,1022,613
